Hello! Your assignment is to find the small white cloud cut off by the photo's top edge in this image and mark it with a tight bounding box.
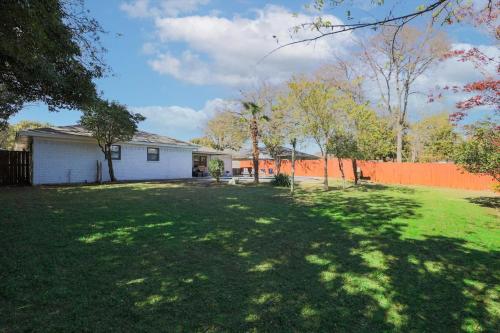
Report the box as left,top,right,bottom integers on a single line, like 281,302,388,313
120,0,210,18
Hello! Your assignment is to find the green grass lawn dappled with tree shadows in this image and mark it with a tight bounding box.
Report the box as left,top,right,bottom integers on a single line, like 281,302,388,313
0,183,500,332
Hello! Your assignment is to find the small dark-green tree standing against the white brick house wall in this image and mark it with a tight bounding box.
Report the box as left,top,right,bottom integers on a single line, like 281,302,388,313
80,100,146,181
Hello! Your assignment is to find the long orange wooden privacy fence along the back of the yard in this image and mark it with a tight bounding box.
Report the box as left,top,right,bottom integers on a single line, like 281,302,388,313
240,159,496,190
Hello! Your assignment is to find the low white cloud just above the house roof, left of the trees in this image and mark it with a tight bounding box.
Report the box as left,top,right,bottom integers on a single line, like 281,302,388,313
130,98,236,140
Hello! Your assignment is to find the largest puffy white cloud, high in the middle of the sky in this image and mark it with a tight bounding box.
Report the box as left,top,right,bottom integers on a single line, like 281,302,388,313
149,6,353,86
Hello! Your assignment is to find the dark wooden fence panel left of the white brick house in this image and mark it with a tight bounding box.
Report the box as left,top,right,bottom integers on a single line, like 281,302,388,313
0,150,31,186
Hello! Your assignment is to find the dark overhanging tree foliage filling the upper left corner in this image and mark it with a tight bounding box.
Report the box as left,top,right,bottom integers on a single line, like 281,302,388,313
0,0,106,126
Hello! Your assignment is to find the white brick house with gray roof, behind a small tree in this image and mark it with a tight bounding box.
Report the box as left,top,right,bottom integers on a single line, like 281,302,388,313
16,126,198,185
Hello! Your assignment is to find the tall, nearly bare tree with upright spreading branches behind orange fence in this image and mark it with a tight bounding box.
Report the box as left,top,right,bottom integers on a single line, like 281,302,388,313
362,26,449,162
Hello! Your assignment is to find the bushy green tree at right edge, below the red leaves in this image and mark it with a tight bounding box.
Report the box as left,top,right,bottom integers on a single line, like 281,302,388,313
455,121,500,182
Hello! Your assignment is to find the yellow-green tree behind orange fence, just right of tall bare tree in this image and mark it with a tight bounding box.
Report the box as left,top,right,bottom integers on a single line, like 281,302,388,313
408,112,459,162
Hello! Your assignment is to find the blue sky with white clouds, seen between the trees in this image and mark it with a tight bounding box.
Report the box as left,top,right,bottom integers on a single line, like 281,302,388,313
11,0,498,140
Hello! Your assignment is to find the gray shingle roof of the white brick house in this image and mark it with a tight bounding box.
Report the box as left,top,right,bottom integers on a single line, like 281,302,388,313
22,125,196,147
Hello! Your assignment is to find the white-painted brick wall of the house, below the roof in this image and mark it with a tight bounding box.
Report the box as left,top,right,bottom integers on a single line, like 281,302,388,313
32,137,192,185
